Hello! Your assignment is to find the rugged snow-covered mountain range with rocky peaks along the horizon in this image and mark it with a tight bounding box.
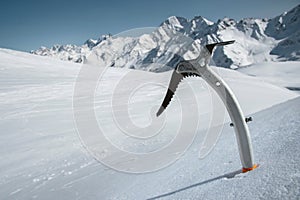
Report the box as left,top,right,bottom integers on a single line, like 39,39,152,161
31,5,300,72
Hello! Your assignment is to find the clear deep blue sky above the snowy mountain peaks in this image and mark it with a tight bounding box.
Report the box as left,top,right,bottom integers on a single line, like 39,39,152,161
0,0,300,51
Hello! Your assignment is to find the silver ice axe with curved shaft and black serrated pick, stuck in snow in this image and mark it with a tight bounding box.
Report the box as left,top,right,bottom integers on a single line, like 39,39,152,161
156,40,257,172
